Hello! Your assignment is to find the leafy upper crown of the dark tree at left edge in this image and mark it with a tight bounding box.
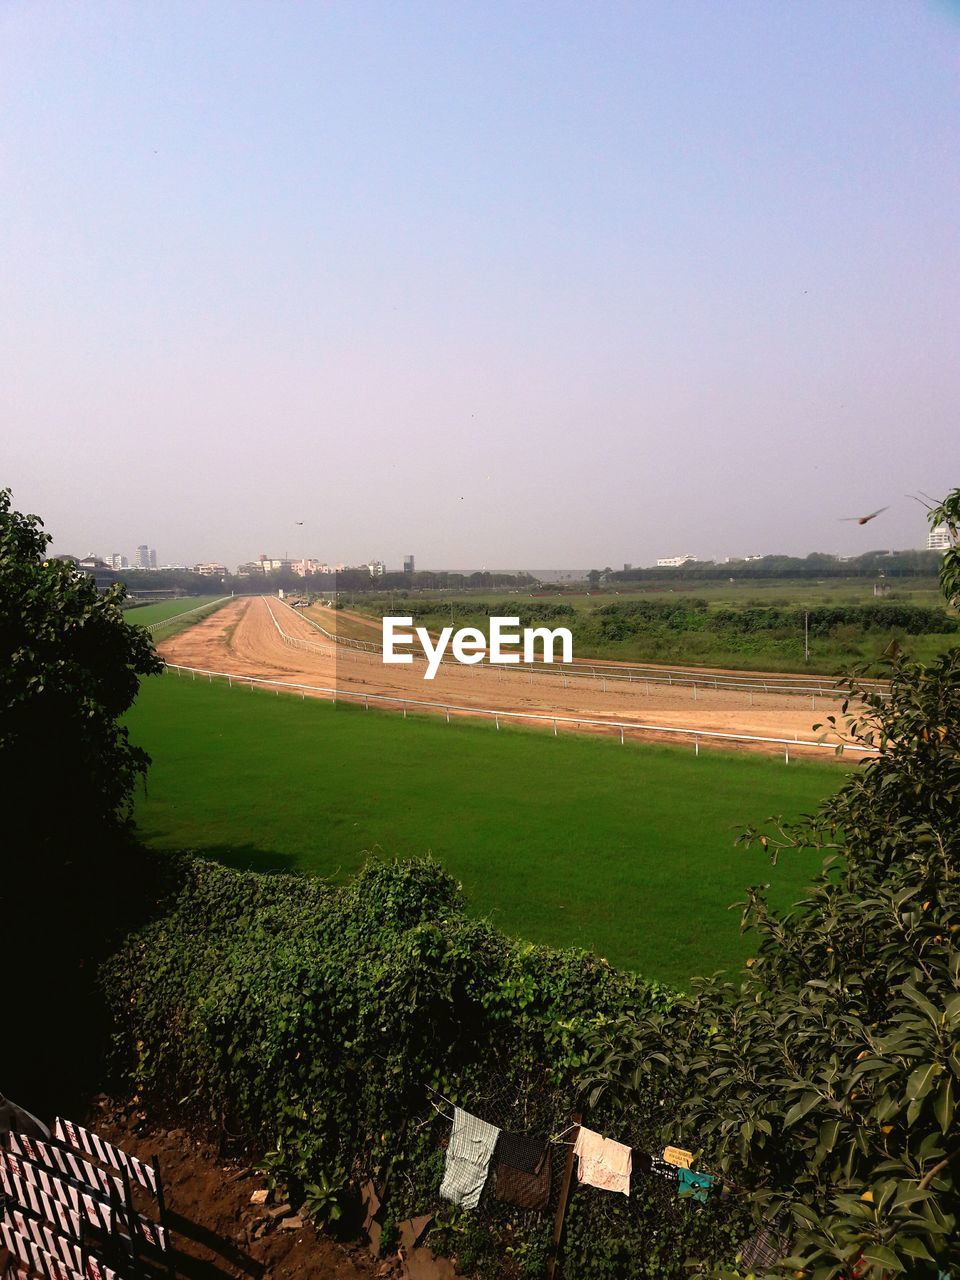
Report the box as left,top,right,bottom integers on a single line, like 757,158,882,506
0,489,163,852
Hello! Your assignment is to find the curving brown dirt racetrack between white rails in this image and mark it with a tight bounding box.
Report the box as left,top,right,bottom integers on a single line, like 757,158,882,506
159,596,870,759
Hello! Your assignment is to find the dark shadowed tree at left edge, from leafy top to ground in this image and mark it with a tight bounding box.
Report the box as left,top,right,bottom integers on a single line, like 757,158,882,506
0,489,163,1111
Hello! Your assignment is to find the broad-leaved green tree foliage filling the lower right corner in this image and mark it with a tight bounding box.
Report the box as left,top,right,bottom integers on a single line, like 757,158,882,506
588,490,960,1280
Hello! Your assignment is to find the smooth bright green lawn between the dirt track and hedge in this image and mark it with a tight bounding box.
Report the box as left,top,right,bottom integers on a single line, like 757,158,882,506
122,673,845,984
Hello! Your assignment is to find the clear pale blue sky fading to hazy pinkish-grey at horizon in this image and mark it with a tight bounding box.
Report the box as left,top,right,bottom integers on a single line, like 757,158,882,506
0,0,960,567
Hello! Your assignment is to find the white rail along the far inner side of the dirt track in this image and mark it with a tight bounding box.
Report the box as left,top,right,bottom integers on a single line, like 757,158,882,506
262,595,886,700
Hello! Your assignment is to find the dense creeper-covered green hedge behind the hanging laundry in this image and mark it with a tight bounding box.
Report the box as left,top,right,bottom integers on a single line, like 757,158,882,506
101,858,742,1280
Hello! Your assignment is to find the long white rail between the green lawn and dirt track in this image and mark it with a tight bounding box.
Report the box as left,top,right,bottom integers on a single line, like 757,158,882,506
166,660,878,764
